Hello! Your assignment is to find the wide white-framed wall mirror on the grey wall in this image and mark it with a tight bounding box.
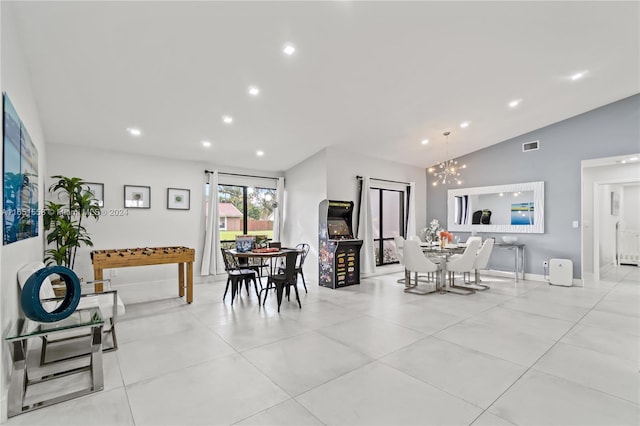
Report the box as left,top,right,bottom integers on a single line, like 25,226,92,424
447,182,544,234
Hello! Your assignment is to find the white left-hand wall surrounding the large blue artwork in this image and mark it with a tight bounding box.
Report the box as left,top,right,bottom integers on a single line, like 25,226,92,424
0,2,46,422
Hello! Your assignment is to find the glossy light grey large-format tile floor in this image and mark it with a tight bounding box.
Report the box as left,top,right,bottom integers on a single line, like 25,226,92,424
8,267,640,426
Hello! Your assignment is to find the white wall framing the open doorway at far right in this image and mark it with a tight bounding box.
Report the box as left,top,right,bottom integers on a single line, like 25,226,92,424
582,163,640,278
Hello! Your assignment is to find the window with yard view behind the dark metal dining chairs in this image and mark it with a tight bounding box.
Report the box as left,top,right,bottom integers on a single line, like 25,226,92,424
218,185,276,246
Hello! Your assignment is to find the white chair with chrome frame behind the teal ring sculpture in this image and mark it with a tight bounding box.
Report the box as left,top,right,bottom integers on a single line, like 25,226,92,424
18,262,125,364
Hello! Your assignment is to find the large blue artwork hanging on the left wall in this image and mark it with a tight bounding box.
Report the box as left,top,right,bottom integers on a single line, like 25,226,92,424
2,93,39,244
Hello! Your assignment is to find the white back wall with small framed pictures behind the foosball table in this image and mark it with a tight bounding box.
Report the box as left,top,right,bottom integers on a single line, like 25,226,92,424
48,144,282,290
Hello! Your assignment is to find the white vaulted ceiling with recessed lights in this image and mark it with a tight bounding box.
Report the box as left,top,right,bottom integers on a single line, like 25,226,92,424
2,1,640,171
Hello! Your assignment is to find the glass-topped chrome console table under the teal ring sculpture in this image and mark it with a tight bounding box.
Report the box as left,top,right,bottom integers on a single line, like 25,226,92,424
5,308,104,417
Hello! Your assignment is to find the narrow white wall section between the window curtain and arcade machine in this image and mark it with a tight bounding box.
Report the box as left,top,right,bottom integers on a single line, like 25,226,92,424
282,150,327,287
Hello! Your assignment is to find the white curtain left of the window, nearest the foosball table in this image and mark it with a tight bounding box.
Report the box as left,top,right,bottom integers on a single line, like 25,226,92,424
200,170,224,276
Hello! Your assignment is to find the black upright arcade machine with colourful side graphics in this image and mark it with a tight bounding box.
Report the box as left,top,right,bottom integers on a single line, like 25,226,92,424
318,200,362,288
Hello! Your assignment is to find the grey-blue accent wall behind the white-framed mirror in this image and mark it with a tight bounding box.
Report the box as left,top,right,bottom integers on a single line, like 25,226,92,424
427,95,640,278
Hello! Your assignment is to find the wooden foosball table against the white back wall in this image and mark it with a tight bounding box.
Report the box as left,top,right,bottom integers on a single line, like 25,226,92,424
91,247,195,303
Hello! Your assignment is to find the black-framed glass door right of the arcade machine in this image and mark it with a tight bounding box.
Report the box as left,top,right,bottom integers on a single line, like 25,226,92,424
371,188,404,266
